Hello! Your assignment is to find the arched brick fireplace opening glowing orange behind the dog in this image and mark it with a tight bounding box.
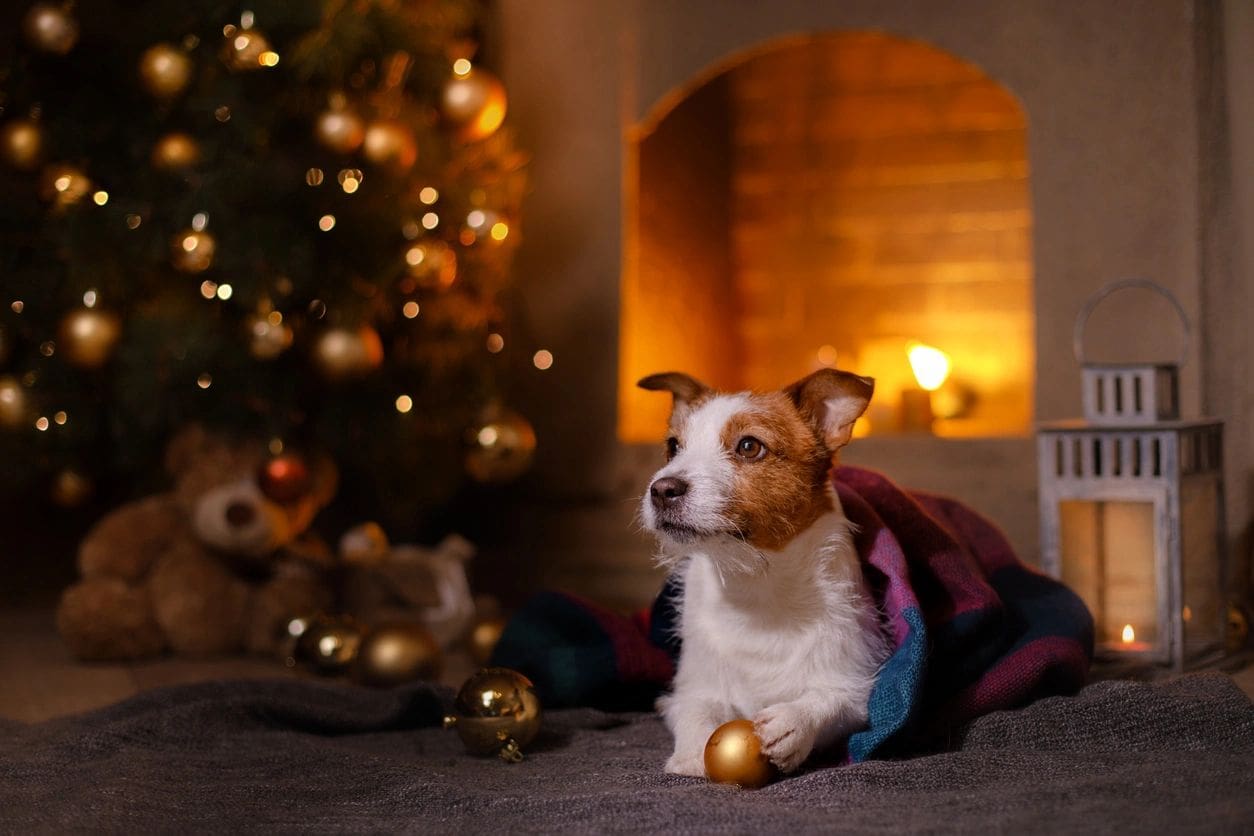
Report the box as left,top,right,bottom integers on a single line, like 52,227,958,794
618,31,1035,442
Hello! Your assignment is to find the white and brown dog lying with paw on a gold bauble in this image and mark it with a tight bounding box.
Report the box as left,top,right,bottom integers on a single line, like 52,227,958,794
638,368,889,777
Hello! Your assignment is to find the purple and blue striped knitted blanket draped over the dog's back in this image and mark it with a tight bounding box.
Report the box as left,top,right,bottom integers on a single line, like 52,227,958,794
493,466,1092,762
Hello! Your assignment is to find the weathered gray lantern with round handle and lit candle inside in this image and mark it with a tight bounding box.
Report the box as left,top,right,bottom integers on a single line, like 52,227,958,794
1037,280,1226,671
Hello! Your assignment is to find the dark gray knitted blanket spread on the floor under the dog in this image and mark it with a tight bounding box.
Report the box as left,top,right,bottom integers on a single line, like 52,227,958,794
0,674,1254,833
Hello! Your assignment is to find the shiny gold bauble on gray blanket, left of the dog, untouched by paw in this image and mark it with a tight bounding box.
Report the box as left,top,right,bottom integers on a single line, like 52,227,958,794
444,668,540,763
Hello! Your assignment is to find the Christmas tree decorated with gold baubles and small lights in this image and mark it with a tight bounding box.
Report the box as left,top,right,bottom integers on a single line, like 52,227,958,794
0,0,534,534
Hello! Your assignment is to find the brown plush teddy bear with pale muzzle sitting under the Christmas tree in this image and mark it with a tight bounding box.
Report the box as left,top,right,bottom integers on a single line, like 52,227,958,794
56,426,337,659
